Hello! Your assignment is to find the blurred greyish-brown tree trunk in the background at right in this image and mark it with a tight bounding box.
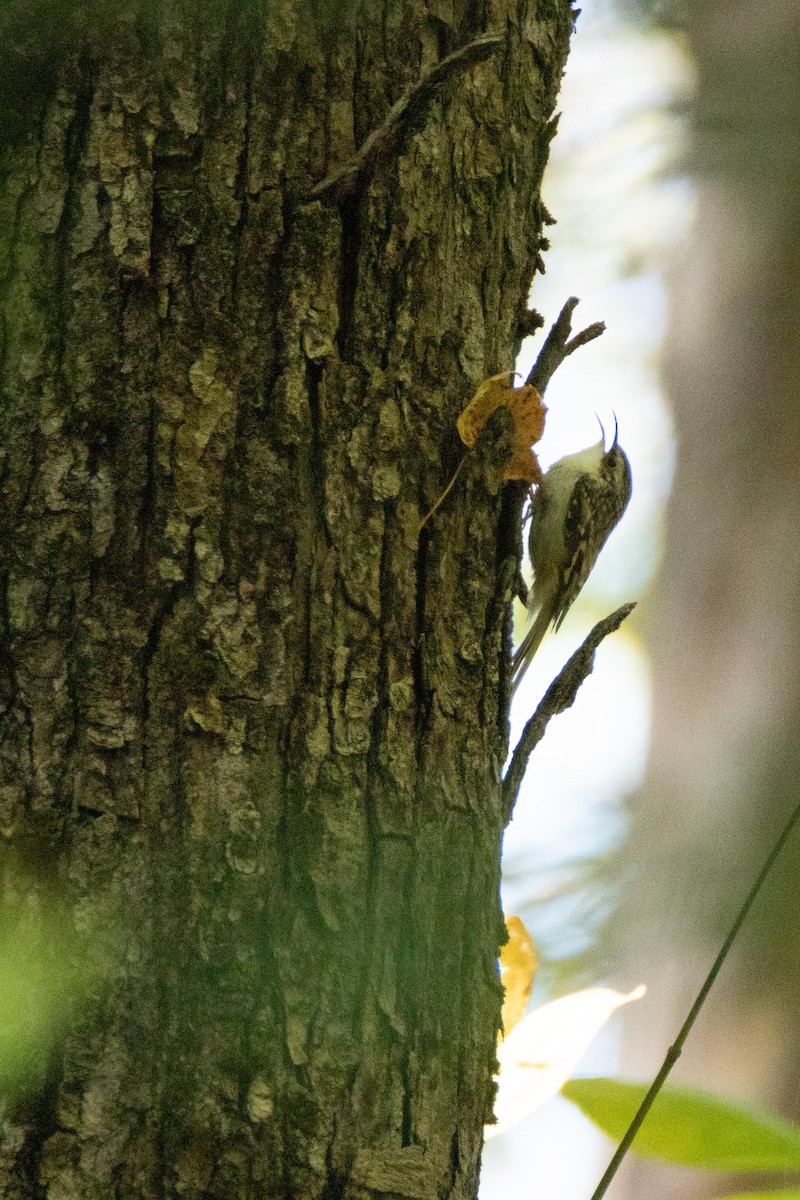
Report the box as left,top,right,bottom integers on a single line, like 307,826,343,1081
620,0,800,1198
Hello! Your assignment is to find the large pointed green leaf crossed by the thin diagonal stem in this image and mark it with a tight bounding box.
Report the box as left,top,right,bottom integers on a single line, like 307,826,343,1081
561,1079,800,1171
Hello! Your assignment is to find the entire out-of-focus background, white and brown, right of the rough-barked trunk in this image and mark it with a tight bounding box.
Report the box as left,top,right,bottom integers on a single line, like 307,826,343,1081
483,0,800,1200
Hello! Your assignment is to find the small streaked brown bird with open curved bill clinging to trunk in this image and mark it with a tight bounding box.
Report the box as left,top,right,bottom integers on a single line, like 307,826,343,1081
511,421,631,694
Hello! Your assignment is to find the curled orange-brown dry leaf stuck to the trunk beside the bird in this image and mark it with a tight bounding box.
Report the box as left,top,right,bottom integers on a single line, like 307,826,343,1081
456,371,547,484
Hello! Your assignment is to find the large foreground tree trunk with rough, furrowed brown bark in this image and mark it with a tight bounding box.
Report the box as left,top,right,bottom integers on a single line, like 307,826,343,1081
0,0,572,1200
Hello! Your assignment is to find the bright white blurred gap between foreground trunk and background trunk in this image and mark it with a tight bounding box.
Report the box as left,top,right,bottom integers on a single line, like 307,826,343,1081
481,0,693,1200
